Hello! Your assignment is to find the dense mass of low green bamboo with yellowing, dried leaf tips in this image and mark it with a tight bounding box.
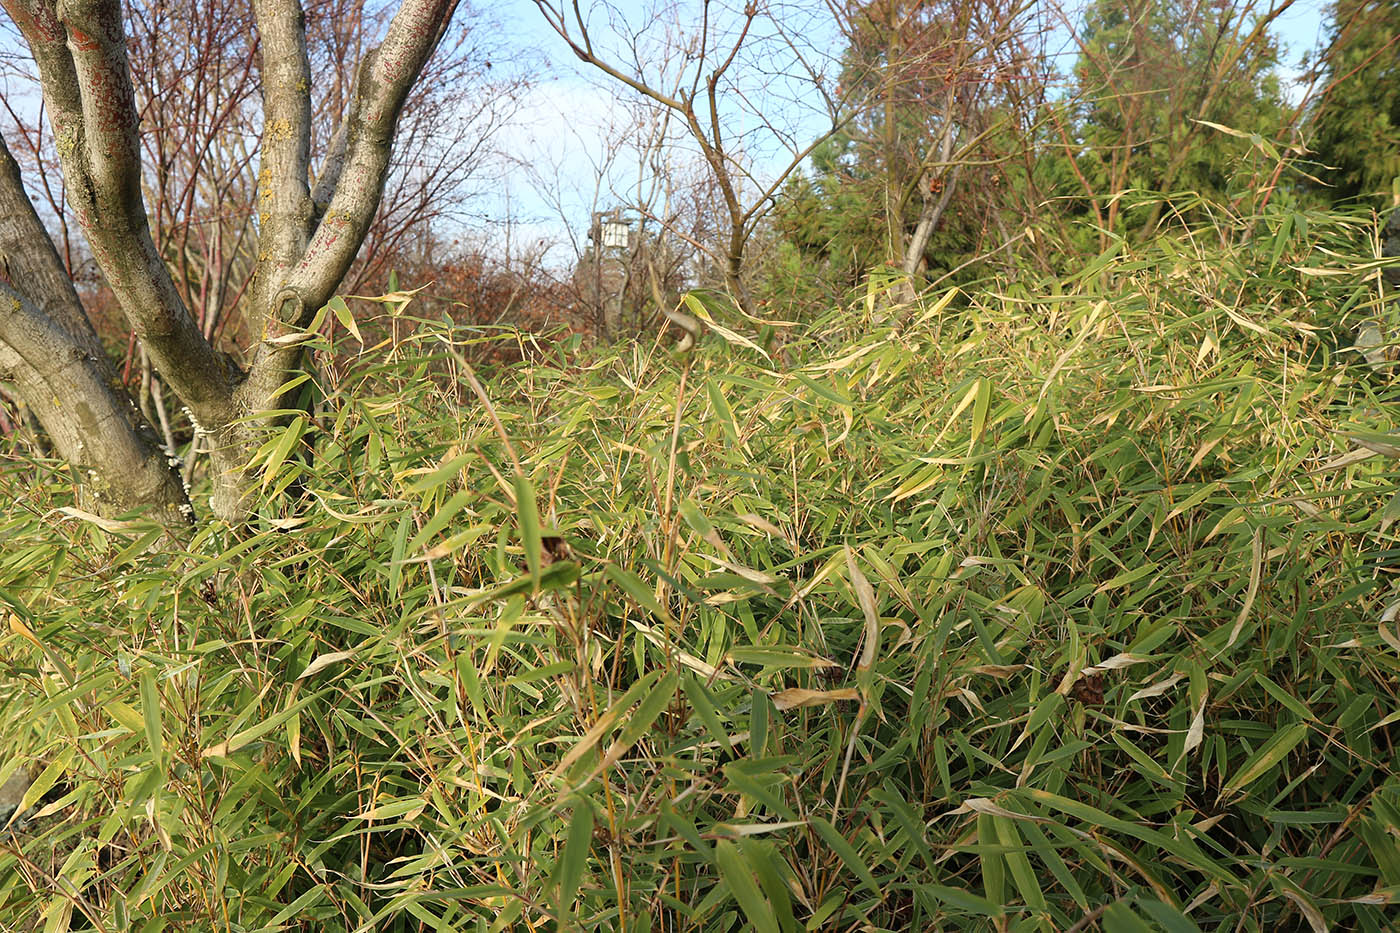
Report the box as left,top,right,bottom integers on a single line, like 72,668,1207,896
0,207,1400,932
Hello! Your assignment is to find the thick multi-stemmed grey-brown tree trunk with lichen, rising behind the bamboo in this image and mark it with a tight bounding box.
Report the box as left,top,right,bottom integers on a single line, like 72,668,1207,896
0,0,458,524
